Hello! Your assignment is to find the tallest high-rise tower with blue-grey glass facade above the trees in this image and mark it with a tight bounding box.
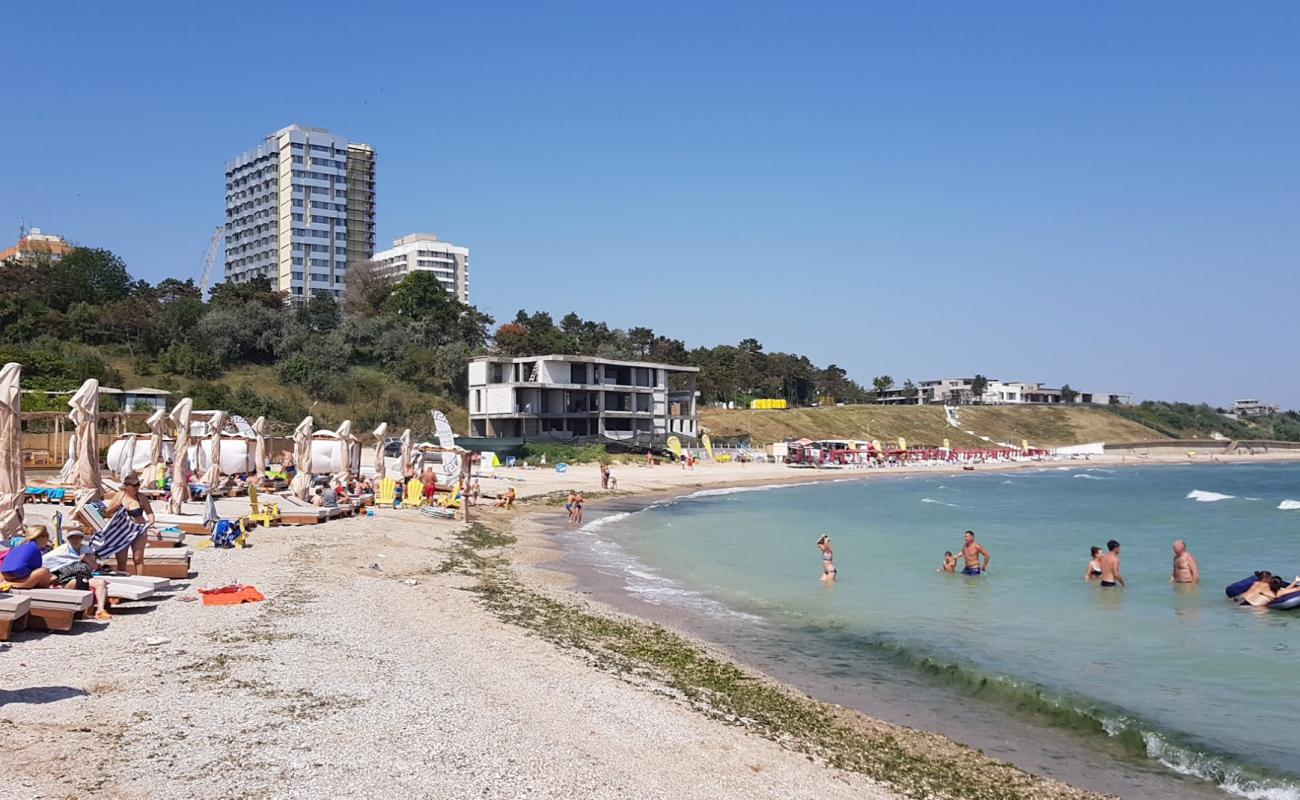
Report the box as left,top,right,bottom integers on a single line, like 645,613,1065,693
225,125,374,304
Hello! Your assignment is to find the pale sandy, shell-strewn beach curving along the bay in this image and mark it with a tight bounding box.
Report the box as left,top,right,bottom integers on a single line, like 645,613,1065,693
0,457,1294,799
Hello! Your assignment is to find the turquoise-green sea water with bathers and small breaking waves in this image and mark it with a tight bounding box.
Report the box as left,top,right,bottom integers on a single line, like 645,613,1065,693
575,464,1300,800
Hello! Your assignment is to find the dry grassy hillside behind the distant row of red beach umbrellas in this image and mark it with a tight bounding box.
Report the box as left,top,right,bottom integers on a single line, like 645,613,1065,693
701,406,1165,447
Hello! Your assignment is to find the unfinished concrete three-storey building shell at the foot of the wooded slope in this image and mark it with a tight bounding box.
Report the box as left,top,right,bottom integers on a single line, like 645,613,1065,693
468,355,699,445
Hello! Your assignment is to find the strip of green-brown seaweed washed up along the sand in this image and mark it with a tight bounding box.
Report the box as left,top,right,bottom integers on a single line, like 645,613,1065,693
449,523,1097,800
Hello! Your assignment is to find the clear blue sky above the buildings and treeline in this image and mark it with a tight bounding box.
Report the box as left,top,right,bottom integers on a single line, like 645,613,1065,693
0,1,1300,407
